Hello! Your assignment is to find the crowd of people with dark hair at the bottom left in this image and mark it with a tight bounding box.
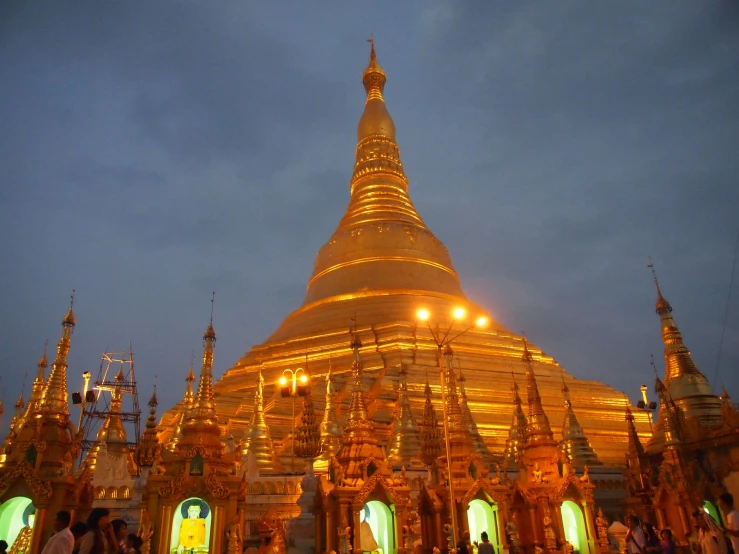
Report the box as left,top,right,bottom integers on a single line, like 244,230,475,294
0,508,143,554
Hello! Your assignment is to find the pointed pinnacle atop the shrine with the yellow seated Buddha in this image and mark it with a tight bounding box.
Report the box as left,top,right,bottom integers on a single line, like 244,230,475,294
180,314,223,452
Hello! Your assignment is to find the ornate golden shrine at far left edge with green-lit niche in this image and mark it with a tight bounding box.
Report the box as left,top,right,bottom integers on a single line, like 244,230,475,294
0,293,92,554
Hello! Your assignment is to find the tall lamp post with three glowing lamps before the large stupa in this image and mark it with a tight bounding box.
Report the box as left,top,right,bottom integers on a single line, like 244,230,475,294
416,308,488,545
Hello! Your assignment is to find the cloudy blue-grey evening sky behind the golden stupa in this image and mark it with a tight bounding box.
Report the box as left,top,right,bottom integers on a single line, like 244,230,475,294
0,0,739,434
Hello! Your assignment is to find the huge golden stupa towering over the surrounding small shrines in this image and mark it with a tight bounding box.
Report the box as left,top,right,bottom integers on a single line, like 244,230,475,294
160,46,648,465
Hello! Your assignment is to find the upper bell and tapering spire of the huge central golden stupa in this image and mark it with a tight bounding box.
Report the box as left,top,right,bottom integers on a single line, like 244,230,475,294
304,43,464,309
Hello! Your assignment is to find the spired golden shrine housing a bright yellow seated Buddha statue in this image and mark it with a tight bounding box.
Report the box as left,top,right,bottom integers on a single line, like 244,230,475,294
137,308,246,554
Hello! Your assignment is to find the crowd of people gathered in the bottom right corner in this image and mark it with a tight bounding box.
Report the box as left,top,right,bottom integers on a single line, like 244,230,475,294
626,493,739,554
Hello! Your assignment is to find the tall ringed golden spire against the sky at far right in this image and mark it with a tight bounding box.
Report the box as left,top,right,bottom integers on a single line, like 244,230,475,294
649,260,721,427
